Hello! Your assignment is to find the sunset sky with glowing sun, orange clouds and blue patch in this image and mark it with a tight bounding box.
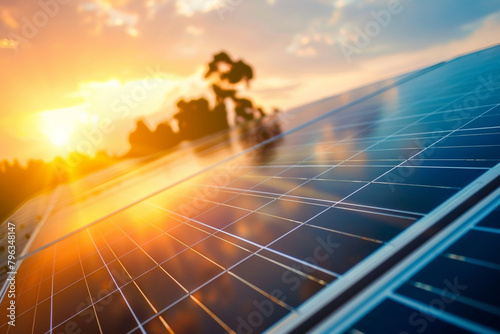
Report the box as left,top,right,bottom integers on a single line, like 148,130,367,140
0,0,500,161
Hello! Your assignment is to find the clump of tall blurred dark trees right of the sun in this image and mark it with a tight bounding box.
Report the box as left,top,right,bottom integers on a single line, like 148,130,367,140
127,52,274,156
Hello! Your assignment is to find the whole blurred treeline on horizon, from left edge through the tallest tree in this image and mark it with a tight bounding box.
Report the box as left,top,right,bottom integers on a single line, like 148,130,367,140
0,52,276,221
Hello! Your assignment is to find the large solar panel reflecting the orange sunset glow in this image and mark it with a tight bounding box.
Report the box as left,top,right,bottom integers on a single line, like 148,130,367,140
0,47,500,333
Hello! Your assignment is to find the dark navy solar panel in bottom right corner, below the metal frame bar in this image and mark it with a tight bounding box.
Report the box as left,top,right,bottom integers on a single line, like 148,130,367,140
318,190,500,333
